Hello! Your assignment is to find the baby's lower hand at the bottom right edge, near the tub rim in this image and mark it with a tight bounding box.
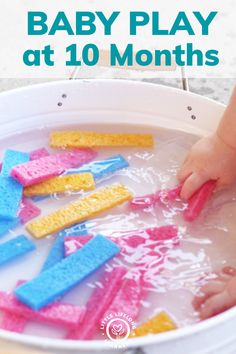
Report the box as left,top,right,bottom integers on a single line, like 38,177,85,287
193,267,236,320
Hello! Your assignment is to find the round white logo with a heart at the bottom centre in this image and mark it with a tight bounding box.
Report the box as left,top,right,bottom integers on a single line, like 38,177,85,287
100,312,136,348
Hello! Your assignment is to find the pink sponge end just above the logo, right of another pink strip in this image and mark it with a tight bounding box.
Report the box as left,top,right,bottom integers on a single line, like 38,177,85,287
104,278,146,320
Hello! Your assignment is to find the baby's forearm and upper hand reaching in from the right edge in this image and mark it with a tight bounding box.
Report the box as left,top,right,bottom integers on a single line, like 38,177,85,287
178,87,236,199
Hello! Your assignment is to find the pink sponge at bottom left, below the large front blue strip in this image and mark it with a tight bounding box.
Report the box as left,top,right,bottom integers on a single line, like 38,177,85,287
0,291,85,329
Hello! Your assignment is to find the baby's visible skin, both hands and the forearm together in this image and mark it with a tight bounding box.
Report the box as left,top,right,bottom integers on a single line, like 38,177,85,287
178,87,236,319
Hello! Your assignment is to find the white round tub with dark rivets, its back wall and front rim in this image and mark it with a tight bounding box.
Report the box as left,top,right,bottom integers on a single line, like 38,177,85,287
0,80,236,354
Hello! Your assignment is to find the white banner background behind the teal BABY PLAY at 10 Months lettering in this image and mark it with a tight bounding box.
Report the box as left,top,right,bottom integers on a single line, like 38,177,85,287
0,0,236,78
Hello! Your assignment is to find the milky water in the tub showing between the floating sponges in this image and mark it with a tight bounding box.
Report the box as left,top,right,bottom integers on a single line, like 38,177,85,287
0,125,236,339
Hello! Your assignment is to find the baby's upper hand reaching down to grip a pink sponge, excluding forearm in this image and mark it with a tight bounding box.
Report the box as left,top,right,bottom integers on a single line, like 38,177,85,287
178,134,236,200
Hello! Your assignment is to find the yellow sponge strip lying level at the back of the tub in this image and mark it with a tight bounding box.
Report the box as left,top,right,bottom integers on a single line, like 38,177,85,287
50,131,154,148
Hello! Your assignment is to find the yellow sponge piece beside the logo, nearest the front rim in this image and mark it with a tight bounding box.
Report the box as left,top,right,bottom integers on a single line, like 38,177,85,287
130,311,177,337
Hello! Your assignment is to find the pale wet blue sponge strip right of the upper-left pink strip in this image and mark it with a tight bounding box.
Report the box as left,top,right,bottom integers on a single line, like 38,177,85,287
66,155,129,180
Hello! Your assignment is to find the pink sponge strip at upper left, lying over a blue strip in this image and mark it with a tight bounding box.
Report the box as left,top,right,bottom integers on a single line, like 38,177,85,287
11,149,97,186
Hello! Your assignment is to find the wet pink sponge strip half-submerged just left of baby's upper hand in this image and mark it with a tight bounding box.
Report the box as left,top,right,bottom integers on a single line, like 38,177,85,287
130,185,182,210
